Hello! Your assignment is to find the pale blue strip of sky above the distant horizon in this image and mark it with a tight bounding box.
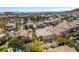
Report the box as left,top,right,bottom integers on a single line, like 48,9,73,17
0,7,75,12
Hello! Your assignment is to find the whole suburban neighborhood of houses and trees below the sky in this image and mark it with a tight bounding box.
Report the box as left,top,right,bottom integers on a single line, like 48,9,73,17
0,9,79,52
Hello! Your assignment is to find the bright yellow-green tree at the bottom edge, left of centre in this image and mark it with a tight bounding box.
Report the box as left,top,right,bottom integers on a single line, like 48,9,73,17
26,40,43,52
